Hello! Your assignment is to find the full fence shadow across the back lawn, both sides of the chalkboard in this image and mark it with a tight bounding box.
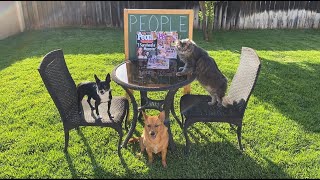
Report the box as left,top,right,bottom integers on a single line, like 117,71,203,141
0,28,320,70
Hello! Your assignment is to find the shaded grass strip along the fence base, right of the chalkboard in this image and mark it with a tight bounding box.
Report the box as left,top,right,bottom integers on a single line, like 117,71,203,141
193,29,320,51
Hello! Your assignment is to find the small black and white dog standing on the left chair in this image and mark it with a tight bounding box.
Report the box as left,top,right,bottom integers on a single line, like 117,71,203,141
77,73,113,119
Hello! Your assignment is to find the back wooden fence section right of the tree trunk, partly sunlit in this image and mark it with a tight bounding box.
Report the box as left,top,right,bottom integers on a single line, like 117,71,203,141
214,1,320,30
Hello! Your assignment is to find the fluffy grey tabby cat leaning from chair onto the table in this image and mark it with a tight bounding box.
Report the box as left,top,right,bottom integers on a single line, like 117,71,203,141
176,39,228,107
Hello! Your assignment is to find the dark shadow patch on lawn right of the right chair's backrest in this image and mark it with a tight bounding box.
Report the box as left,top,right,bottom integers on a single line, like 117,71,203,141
253,59,320,133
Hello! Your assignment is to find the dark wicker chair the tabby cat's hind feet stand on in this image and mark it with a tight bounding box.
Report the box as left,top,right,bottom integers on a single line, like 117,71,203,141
180,47,261,154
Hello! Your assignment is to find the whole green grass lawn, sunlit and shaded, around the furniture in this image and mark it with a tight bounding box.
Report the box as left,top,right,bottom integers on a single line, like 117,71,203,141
0,28,320,178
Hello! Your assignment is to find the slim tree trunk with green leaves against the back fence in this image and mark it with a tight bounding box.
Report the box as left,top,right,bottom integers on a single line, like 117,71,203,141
199,1,214,41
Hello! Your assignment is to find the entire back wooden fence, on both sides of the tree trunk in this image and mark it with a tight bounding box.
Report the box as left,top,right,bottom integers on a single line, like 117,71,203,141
21,1,320,30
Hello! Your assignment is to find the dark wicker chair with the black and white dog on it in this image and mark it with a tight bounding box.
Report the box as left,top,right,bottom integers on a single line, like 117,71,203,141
38,49,129,155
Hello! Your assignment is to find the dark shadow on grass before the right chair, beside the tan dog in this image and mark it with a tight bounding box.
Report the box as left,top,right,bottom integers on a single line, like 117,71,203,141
136,142,290,179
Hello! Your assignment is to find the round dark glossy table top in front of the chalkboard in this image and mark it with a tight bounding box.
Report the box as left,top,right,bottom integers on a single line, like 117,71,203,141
111,61,195,91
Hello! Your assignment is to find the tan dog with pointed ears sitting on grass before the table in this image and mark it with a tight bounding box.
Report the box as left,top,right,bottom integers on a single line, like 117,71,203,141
129,111,169,167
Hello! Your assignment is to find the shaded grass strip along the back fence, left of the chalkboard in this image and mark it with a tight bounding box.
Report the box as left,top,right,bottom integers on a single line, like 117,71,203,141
0,28,124,70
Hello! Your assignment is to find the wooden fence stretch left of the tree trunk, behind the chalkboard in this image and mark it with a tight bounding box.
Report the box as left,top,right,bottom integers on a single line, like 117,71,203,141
21,1,197,30
